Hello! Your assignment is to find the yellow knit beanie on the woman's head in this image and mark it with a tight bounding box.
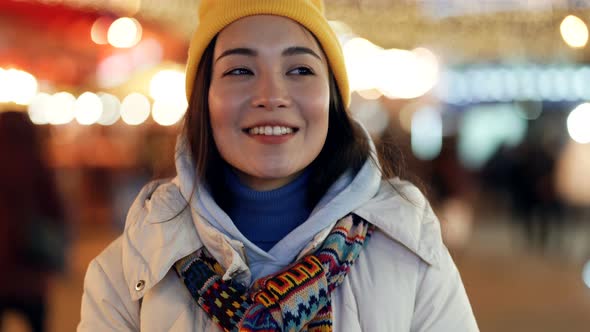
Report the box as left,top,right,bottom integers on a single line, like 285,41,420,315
186,0,350,106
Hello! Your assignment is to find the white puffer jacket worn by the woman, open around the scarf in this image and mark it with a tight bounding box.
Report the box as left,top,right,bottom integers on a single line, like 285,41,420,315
78,136,478,332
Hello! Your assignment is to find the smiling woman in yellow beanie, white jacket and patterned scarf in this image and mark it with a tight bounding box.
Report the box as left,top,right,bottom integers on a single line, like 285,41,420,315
78,0,477,331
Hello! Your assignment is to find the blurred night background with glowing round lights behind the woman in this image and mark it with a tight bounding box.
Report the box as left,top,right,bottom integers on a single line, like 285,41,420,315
0,0,590,332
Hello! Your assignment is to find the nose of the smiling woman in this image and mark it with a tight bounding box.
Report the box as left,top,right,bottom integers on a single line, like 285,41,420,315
252,73,292,111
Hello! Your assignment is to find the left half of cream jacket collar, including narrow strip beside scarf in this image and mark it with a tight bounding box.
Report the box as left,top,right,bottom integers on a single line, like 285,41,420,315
122,179,250,300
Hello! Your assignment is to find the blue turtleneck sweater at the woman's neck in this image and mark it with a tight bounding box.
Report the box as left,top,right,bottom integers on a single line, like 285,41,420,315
225,169,311,251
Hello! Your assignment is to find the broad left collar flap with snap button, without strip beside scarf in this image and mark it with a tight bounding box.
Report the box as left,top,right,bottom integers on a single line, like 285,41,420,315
122,180,202,300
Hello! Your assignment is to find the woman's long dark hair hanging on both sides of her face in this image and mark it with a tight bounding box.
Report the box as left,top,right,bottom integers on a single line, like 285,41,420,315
183,38,402,209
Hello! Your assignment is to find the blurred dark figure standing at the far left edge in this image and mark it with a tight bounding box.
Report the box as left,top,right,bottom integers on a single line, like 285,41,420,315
0,111,65,332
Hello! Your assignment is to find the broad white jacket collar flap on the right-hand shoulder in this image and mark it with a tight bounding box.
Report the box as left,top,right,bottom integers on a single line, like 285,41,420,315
354,178,446,266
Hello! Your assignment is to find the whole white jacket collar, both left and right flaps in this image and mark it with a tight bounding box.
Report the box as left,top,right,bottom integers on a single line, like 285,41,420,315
122,134,442,300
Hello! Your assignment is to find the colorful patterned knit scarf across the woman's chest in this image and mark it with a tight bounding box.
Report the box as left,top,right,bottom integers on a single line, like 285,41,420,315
175,214,374,332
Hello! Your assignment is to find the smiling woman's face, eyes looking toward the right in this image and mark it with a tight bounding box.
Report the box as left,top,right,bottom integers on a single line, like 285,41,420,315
208,15,330,190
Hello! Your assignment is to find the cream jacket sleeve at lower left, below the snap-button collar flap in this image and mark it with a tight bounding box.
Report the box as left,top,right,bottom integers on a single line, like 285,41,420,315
78,239,139,332
